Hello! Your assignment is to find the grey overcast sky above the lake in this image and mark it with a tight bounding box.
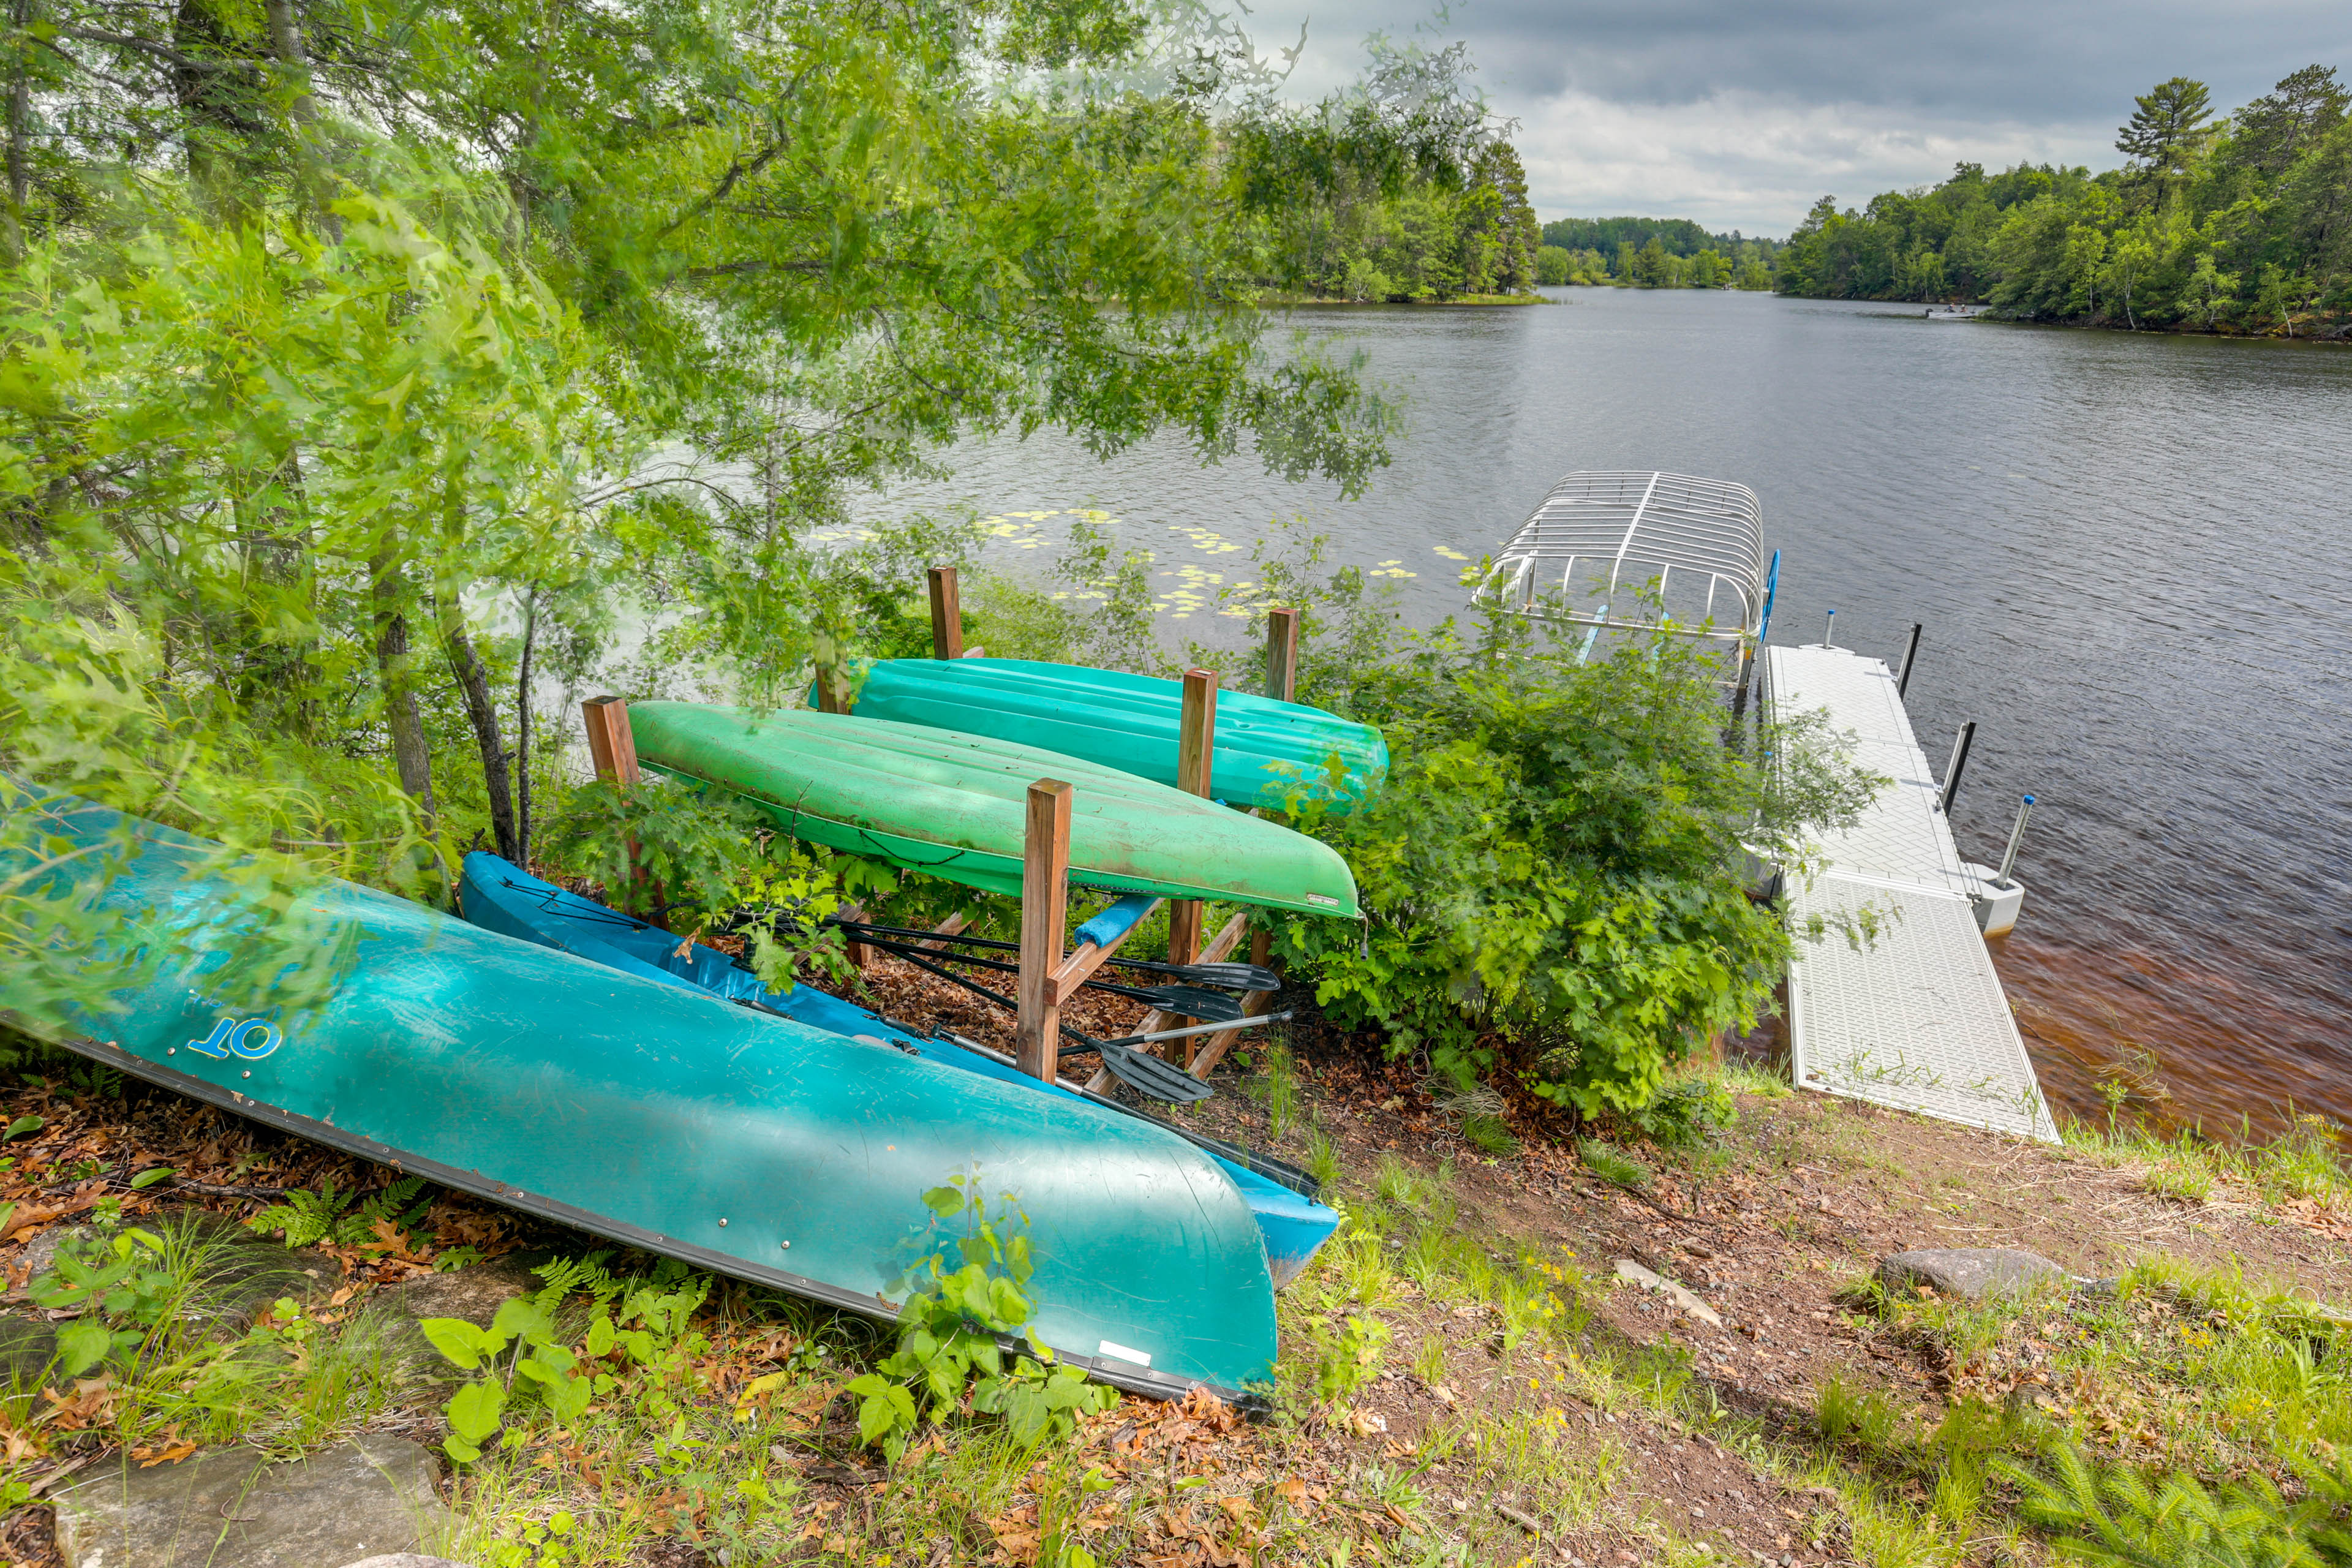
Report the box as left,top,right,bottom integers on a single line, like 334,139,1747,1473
1246,0,2352,235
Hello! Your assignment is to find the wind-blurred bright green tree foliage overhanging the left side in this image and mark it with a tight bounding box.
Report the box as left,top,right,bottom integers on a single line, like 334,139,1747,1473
0,0,1439,968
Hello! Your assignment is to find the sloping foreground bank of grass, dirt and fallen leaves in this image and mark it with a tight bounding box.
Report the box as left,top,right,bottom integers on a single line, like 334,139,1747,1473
0,1037,2352,1568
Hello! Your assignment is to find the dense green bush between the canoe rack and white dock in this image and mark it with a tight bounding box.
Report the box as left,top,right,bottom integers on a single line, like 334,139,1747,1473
1265,557,1874,1117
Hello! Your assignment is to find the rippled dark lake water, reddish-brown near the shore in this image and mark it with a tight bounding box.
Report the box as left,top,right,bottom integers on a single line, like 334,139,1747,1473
889,289,2352,1128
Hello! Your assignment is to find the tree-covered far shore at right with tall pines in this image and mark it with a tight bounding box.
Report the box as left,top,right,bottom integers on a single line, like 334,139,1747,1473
1778,66,2352,336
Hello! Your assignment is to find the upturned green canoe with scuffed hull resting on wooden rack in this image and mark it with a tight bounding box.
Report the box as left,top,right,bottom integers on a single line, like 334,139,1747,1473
628,703,1357,917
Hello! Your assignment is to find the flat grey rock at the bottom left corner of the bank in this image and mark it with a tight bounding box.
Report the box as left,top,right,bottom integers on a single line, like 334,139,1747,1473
56,1431,447,1568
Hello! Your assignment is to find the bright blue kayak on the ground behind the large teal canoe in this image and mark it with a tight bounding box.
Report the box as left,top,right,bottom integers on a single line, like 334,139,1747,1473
459,851,1338,1288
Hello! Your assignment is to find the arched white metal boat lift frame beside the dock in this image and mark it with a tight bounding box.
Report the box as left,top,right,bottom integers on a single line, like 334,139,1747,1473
1472,470,1771,654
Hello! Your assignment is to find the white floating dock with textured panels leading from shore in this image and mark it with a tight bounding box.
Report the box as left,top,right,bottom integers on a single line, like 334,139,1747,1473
1764,646,2058,1142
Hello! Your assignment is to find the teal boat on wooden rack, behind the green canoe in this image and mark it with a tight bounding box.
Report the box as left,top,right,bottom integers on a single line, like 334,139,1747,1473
859,658,1388,816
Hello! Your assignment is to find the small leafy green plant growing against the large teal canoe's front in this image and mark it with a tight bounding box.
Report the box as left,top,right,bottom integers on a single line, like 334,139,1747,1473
849,1170,1120,1460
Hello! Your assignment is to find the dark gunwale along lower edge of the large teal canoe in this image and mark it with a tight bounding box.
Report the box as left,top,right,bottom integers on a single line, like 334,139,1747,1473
13,1009,1268,1415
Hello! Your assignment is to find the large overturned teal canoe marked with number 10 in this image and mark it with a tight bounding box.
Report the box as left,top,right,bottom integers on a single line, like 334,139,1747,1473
0,797,1275,1396
